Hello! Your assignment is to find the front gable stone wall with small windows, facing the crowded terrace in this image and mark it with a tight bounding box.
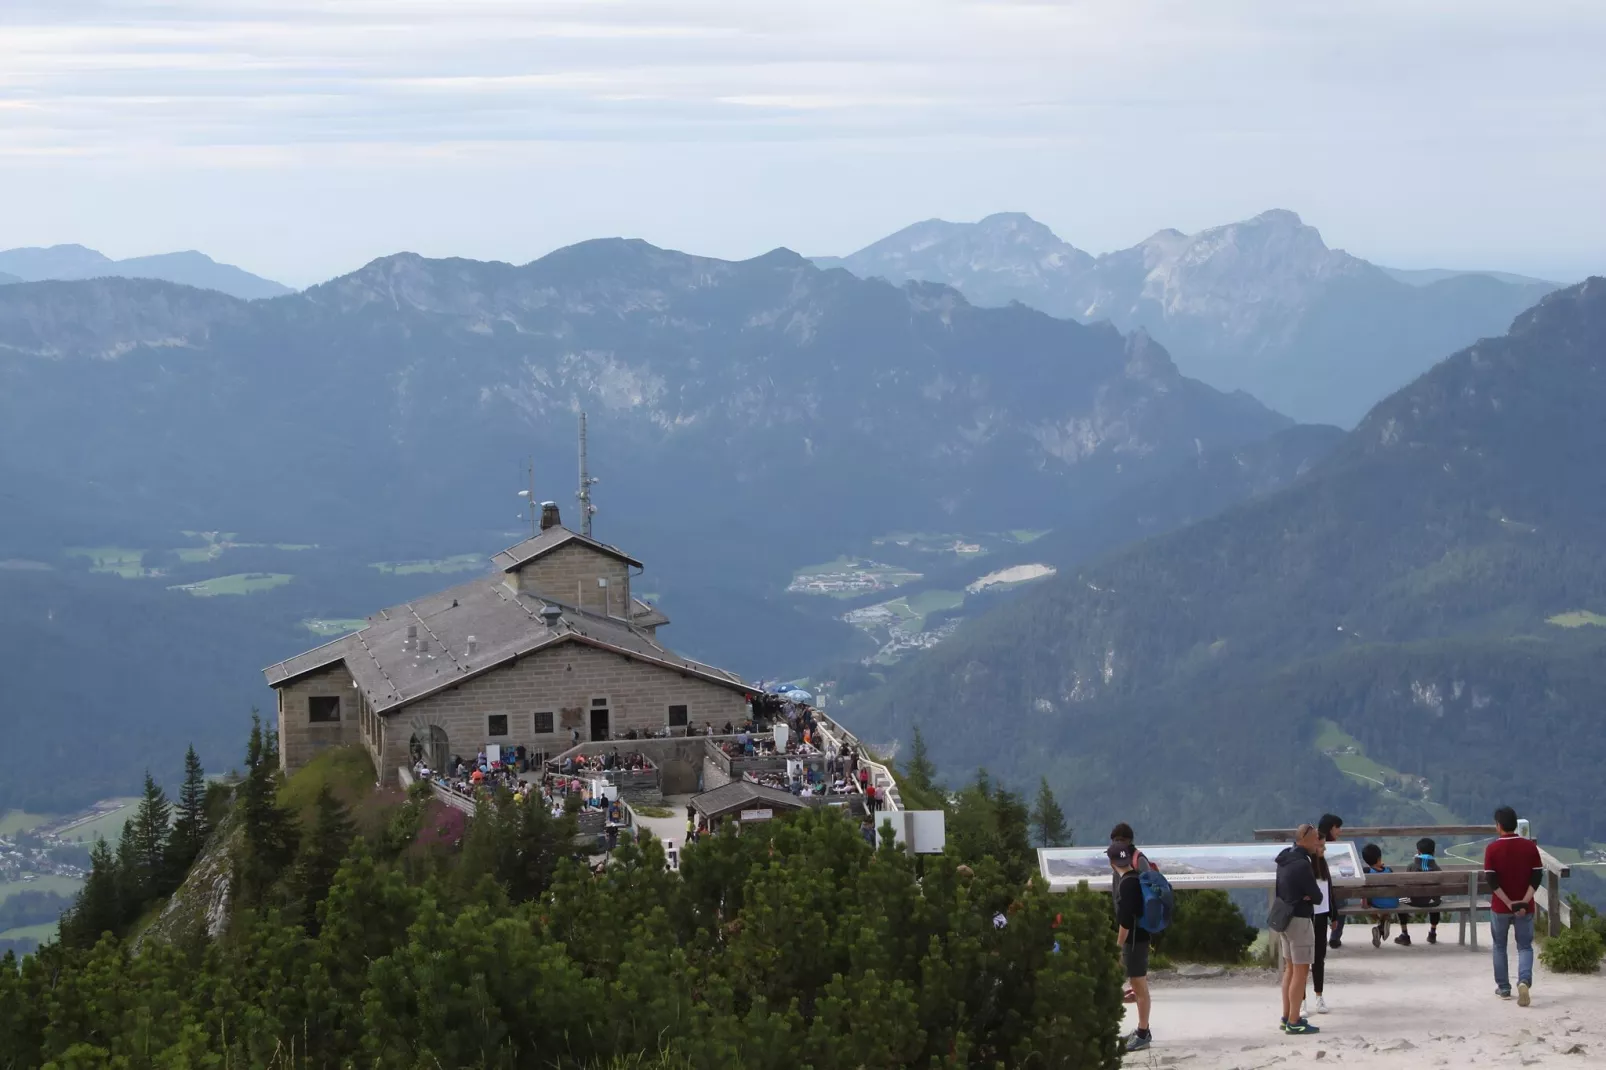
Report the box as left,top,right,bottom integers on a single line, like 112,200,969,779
372,643,747,794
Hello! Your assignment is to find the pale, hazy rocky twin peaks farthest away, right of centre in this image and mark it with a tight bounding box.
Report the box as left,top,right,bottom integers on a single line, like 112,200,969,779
816,210,1555,427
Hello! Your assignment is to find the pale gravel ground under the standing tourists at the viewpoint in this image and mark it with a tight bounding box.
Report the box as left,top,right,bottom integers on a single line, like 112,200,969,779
1124,925,1606,1070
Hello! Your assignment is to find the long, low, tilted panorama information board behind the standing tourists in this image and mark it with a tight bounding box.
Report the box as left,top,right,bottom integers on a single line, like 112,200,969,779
1037,840,1363,888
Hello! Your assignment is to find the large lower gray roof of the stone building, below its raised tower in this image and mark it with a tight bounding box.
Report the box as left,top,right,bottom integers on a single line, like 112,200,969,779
262,575,748,713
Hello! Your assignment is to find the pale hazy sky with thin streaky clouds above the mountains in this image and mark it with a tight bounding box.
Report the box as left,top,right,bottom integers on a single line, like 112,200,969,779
0,0,1606,286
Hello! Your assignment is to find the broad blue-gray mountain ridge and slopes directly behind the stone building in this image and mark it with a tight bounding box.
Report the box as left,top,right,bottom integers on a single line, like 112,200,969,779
0,239,1290,807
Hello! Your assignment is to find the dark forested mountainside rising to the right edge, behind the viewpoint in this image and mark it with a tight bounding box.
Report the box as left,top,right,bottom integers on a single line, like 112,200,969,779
846,278,1606,847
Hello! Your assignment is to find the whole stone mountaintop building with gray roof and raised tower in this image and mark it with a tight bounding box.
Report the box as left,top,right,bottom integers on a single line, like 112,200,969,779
263,503,752,784
